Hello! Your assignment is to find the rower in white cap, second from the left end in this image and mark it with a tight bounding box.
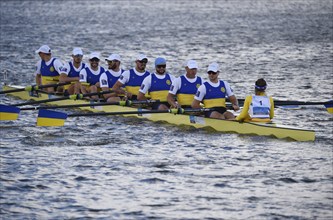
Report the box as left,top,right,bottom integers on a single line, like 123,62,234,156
59,47,86,95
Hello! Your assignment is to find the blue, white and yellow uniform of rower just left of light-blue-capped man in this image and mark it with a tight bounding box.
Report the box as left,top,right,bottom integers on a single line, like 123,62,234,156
118,68,150,100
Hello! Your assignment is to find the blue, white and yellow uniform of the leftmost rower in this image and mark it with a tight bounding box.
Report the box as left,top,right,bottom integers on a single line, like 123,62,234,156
35,57,63,85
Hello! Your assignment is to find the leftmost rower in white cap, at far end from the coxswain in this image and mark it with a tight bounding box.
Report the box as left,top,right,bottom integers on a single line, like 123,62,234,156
35,45,63,93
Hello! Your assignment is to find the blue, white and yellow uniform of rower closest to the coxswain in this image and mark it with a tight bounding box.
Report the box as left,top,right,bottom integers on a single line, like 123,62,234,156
194,80,234,118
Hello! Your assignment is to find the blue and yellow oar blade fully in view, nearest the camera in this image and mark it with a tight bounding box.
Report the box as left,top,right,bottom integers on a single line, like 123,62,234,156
37,109,67,126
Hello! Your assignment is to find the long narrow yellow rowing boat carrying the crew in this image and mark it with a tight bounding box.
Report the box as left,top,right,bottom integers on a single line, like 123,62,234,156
3,85,315,141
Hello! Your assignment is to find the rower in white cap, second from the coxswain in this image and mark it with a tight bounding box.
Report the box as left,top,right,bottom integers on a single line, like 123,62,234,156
167,60,203,108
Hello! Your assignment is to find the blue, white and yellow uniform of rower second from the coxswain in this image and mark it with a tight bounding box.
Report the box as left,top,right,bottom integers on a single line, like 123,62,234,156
169,75,203,107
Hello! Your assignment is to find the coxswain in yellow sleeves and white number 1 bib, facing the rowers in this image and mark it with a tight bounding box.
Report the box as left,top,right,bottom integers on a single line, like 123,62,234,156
236,78,274,122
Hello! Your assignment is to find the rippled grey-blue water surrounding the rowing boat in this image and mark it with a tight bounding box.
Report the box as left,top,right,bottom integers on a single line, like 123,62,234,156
0,0,333,219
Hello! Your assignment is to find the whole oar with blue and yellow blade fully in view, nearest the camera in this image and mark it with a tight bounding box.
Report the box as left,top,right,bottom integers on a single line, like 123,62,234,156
37,108,211,126
